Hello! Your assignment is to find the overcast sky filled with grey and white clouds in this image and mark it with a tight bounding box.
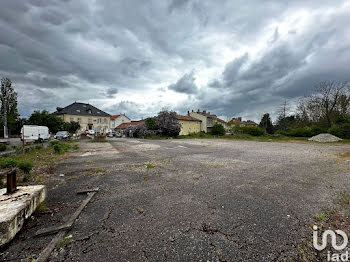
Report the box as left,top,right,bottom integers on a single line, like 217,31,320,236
0,0,350,120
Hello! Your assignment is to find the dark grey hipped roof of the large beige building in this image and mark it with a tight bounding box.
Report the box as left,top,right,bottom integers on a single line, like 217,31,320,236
53,102,110,116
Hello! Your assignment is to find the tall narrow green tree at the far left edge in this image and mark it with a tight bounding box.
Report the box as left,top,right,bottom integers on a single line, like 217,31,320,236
0,78,19,138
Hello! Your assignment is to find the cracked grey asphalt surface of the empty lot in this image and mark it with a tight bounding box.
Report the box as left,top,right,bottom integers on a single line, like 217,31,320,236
0,138,350,261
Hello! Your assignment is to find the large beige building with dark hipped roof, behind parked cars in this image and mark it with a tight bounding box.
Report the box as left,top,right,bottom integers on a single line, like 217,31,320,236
53,102,111,132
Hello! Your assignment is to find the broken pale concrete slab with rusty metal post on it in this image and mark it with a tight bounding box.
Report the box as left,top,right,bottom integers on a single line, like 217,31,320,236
0,185,46,246
